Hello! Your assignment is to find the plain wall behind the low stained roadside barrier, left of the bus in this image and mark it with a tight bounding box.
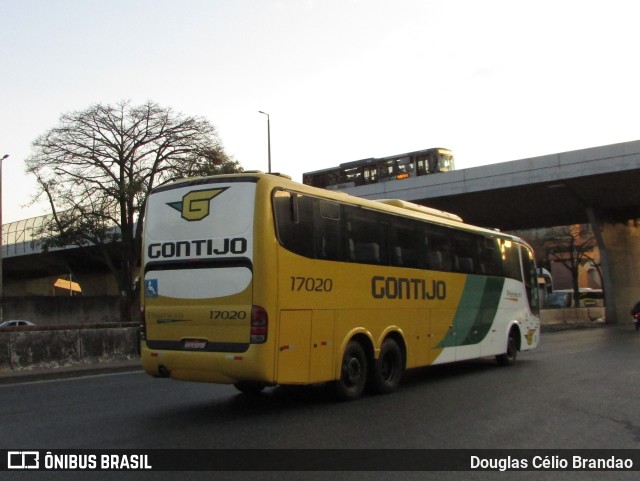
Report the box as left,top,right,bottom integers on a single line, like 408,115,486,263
2,296,121,326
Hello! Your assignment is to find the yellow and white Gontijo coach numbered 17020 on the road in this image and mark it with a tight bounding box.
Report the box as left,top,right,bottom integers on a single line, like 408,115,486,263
141,172,540,400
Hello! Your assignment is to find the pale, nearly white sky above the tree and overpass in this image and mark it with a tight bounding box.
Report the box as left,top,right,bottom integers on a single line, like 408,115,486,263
0,0,640,223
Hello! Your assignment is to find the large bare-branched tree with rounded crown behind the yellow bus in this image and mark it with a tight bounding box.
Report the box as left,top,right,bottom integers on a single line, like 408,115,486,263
26,101,242,321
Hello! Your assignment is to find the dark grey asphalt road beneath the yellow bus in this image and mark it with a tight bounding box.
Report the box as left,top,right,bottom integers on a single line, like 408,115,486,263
0,326,640,479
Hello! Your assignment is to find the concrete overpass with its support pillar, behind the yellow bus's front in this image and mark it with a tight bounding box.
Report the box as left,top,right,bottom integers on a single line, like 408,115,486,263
336,137,640,322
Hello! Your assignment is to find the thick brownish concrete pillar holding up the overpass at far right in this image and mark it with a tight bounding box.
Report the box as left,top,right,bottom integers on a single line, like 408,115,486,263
588,213,640,323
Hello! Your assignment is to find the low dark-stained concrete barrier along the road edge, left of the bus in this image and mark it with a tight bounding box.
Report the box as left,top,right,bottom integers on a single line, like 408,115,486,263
0,324,137,375
